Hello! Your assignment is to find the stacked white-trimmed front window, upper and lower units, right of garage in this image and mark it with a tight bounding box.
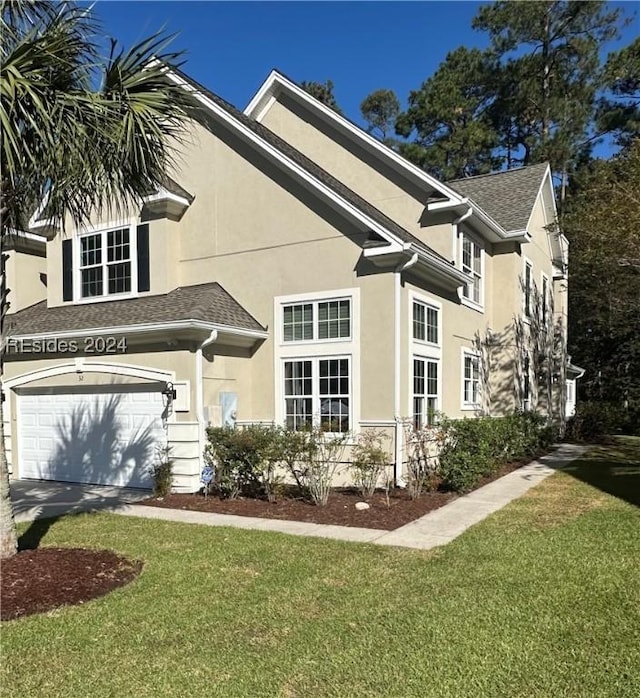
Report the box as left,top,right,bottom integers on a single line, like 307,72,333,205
276,289,357,434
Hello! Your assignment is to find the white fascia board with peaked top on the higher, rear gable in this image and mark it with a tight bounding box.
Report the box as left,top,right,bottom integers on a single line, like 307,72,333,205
244,70,461,204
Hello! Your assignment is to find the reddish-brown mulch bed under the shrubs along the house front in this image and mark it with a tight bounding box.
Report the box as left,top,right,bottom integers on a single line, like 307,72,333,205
139,458,532,531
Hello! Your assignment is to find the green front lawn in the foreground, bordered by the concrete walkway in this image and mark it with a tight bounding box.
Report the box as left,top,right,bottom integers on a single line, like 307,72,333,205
5,439,640,698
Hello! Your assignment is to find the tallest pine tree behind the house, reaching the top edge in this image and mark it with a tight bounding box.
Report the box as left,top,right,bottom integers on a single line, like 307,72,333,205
473,0,621,199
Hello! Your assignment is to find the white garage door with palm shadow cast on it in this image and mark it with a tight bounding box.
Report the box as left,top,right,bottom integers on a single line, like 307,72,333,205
18,388,166,487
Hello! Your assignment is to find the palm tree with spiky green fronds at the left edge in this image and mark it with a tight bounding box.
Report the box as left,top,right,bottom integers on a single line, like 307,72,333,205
0,0,195,559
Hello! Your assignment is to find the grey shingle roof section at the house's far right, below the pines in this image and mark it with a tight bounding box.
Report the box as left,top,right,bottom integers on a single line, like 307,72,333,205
447,162,547,232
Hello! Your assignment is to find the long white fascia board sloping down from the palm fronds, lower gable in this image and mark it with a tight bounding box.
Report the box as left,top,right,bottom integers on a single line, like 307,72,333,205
162,72,410,251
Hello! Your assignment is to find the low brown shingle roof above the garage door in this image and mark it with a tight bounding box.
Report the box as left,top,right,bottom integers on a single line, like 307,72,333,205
5,282,265,336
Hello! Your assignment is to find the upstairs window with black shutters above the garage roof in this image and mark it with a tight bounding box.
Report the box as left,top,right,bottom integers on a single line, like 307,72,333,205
62,223,150,301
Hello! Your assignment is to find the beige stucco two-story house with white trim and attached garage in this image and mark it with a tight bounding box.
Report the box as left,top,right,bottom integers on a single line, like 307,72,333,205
4,65,567,491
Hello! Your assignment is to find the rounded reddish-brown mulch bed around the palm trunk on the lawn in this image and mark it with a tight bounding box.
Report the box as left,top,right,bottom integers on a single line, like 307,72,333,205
0,548,142,620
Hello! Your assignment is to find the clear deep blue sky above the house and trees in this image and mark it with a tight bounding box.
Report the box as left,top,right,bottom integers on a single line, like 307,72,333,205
95,0,640,129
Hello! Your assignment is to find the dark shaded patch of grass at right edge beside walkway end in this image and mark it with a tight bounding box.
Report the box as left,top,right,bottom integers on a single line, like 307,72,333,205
562,436,640,507
